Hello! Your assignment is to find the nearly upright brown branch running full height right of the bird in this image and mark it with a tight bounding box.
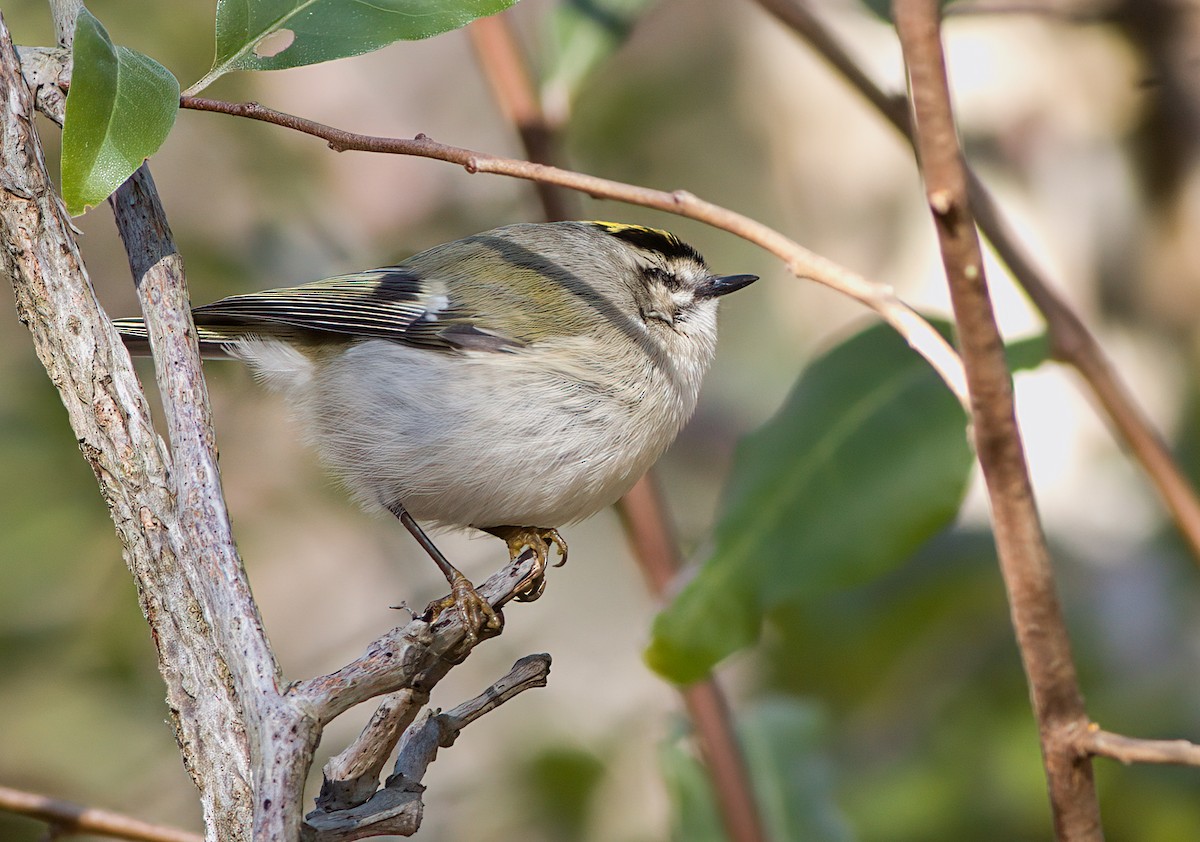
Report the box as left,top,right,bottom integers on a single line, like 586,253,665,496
893,0,1103,841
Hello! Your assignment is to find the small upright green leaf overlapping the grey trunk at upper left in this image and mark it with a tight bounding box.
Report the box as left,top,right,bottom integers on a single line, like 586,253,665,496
62,8,179,216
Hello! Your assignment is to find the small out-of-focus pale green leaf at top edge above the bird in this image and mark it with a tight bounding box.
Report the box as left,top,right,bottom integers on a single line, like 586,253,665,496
545,0,653,101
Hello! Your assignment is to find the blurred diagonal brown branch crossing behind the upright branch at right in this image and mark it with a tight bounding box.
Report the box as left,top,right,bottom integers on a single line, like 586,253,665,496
756,0,1200,564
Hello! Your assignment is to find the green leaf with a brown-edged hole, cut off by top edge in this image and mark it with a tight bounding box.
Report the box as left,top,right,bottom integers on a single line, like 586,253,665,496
188,0,516,94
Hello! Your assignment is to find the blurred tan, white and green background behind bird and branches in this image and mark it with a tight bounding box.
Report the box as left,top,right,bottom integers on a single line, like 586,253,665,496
0,0,1200,842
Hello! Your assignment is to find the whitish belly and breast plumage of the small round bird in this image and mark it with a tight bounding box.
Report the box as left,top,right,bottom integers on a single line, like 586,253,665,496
235,337,707,528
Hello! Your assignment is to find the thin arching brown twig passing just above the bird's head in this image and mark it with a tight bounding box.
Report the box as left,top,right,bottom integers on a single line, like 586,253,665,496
180,96,967,405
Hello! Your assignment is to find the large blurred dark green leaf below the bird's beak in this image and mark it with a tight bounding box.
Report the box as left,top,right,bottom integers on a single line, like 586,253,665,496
646,325,972,682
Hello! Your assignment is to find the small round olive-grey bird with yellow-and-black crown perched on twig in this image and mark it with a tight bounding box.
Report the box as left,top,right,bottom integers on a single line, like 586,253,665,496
116,222,756,630
